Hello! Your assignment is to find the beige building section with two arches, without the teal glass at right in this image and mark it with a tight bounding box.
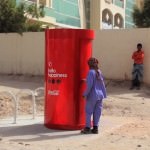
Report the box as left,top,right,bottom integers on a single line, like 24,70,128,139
90,0,126,29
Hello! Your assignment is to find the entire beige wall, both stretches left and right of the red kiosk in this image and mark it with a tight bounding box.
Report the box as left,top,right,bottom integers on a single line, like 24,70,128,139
0,29,150,84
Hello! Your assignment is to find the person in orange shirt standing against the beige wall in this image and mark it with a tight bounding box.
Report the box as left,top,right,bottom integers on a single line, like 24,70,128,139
130,43,144,90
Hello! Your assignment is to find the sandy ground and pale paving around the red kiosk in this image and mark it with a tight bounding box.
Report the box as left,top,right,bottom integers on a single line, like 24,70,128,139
0,75,150,150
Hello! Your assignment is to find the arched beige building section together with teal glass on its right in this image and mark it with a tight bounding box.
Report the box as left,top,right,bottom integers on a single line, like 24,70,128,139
90,0,139,29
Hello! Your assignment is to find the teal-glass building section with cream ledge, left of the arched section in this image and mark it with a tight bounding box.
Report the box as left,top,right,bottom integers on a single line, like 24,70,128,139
16,0,86,28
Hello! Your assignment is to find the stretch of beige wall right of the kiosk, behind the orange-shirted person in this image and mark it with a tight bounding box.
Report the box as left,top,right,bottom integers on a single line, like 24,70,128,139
93,29,150,84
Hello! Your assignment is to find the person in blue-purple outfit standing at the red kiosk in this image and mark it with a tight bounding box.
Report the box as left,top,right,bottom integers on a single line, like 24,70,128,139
81,58,106,134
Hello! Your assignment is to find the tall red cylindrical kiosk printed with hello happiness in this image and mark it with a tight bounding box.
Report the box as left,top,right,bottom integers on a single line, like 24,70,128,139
44,29,94,130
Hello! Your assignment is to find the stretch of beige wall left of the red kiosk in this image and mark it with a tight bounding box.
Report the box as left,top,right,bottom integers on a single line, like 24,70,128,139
0,32,45,75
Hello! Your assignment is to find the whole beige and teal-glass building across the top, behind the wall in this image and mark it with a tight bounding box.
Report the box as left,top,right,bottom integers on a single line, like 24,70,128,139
16,0,143,30
